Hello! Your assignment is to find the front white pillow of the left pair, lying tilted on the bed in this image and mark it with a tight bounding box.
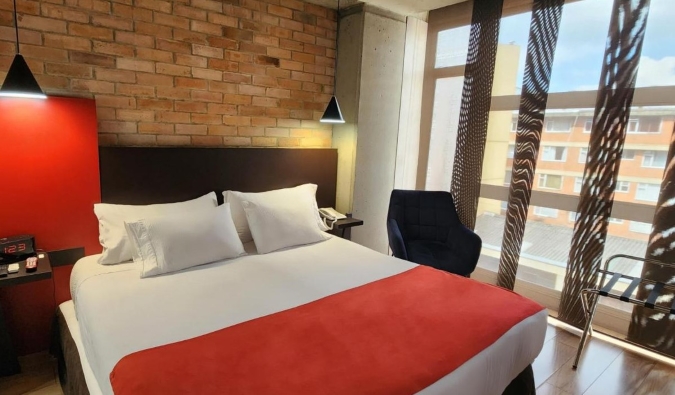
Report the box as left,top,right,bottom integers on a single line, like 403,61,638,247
125,203,244,278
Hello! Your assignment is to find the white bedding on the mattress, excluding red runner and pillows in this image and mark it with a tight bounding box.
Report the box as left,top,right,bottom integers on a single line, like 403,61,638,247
69,237,547,395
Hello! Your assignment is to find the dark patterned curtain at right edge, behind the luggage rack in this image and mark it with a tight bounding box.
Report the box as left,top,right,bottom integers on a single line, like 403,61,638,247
628,126,675,356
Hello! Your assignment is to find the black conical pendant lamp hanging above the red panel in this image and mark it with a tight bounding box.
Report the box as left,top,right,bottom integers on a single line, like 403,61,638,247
0,0,47,99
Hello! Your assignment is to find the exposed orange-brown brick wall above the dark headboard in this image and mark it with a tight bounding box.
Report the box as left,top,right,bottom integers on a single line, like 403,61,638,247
0,0,336,147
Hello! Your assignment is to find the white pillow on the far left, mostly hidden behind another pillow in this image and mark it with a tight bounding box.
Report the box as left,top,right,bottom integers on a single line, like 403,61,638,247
94,192,218,265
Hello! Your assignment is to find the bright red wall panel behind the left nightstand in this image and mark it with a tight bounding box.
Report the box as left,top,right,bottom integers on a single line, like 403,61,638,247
0,97,101,355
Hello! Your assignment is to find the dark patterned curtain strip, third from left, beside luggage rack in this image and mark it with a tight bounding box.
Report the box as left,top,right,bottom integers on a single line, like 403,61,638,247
558,0,649,328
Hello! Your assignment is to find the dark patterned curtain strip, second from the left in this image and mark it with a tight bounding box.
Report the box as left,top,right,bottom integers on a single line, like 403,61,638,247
497,0,565,289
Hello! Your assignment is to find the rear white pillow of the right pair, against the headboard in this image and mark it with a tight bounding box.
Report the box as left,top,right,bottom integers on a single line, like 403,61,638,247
223,184,328,243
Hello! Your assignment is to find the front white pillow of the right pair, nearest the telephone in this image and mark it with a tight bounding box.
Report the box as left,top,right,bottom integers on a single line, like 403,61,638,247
242,196,329,254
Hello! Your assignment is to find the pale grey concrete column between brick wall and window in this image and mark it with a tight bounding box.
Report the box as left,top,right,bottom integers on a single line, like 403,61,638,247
333,4,406,253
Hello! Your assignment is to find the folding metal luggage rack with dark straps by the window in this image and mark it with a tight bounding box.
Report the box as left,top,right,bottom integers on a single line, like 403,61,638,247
572,254,675,369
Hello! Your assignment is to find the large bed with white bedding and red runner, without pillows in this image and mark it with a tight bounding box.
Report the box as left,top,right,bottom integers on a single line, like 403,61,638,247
52,149,547,394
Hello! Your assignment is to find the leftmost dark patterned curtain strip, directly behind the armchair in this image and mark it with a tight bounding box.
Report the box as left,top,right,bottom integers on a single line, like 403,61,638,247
450,0,503,229
